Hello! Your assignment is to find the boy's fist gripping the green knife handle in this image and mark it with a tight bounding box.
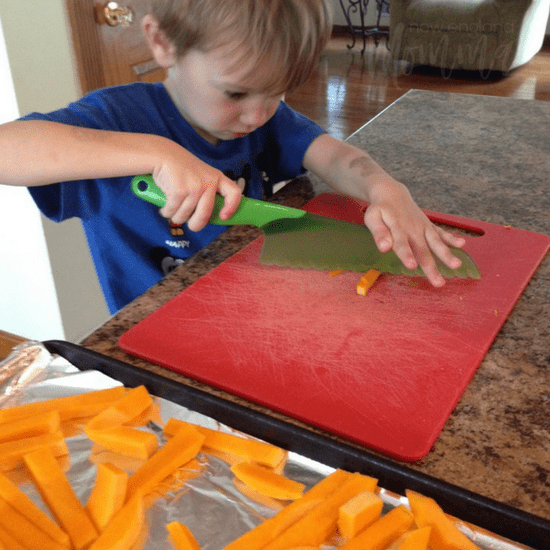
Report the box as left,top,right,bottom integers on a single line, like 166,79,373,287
152,149,242,231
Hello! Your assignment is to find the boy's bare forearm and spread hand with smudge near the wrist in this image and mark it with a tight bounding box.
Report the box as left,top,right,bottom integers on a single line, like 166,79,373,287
304,134,464,286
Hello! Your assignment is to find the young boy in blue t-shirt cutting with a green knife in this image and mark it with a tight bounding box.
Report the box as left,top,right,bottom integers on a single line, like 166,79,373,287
0,0,463,313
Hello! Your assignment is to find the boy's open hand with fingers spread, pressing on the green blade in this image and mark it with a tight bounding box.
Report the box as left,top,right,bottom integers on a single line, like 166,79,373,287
365,177,465,287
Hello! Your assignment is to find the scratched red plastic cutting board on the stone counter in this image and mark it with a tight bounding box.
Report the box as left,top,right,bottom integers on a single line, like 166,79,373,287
119,194,550,461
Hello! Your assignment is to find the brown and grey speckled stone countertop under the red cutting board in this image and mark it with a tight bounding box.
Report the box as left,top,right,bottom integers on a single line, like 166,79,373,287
81,91,550,528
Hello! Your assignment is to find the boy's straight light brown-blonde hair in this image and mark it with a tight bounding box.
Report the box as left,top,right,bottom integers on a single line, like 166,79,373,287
150,0,333,93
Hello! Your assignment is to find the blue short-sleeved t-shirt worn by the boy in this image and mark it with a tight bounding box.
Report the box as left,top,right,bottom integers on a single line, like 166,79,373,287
23,83,324,313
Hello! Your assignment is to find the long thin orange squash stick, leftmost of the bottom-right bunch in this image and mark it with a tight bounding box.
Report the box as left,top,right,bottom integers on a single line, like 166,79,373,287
224,470,351,550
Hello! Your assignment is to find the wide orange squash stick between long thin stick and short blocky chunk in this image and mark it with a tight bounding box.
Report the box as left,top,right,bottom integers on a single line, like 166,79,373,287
262,474,378,550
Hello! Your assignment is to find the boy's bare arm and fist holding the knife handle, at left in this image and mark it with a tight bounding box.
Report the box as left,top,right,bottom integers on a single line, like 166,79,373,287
0,120,241,231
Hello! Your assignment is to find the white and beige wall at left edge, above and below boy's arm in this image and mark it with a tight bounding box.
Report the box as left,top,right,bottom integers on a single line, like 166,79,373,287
0,0,109,342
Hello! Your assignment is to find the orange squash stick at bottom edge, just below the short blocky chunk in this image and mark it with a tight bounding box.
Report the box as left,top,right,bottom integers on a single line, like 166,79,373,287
340,506,414,550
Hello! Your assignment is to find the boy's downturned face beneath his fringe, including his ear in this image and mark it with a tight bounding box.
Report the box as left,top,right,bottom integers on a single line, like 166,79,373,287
165,48,283,144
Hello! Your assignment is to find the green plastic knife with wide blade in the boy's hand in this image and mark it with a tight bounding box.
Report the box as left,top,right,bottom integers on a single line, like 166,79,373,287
132,175,481,279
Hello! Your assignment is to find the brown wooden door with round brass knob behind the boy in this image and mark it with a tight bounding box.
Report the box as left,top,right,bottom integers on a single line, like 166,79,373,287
65,0,165,94
